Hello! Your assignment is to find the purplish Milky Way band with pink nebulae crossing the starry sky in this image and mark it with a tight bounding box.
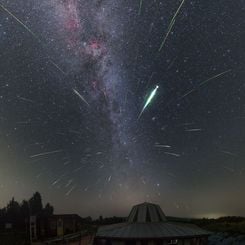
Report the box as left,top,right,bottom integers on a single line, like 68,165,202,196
44,0,144,182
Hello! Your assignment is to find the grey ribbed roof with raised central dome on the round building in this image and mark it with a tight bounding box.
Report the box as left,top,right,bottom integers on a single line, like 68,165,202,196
96,203,210,239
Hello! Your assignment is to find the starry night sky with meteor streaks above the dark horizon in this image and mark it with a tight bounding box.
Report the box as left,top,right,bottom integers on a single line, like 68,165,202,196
0,0,245,217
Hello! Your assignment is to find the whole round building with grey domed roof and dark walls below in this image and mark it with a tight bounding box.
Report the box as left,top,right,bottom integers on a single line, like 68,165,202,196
94,203,210,245
